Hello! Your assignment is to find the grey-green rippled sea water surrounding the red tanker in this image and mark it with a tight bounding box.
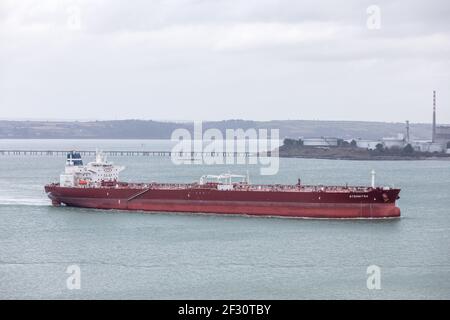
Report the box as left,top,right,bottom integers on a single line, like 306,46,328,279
0,140,450,299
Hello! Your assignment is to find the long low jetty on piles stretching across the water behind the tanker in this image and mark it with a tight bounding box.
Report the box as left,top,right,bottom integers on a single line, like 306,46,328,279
0,149,271,158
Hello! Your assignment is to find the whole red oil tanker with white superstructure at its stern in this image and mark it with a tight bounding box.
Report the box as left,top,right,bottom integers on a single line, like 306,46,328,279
45,152,400,218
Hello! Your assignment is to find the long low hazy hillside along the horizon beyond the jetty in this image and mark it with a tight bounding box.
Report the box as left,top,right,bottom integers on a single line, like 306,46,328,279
0,120,431,139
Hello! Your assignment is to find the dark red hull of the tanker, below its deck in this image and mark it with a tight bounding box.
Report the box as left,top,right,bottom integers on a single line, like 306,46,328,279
46,186,400,219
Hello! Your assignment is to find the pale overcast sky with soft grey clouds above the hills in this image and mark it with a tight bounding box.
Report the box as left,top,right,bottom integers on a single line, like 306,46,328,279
0,0,450,123
